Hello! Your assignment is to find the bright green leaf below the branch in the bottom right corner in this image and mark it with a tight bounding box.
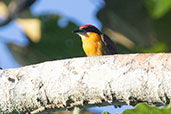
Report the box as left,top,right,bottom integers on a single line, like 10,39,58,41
122,103,171,114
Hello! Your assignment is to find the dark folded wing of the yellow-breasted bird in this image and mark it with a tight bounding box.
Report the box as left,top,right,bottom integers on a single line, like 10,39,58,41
101,34,117,55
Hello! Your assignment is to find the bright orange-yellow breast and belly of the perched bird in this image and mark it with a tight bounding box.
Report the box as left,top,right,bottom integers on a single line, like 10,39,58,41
82,33,102,56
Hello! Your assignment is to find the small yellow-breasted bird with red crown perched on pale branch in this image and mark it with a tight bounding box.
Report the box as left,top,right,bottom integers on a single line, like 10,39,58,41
73,24,117,56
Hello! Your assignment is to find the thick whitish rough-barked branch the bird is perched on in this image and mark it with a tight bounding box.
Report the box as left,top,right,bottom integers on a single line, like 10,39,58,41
0,53,171,113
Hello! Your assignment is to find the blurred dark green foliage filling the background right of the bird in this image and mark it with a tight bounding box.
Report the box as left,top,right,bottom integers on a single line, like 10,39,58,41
97,0,171,53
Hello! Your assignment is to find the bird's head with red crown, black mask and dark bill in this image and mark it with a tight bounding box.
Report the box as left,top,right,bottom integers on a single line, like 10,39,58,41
73,24,101,38
